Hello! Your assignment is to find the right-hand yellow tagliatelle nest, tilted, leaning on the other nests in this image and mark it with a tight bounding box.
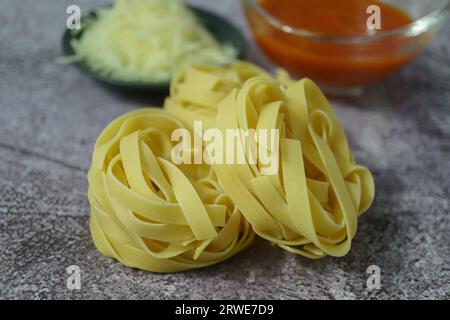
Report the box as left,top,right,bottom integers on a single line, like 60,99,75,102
214,77,375,258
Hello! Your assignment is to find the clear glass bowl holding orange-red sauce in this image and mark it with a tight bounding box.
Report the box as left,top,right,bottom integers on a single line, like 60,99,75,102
241,0,450,92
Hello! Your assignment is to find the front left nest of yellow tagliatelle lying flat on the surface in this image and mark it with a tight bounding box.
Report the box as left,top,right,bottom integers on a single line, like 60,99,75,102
88,108,254,272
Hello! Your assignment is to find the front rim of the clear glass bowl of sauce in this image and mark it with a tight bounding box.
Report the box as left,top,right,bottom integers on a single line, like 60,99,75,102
242,0,450,44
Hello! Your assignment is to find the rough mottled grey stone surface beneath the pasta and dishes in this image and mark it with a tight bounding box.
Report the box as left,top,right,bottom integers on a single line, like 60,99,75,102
0,0,450,299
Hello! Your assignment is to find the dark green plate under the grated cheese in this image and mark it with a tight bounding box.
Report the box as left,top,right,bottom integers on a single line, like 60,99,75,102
62,6,245,91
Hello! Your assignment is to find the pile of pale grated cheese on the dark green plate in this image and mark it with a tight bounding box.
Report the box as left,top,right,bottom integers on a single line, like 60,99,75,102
70,0,236,82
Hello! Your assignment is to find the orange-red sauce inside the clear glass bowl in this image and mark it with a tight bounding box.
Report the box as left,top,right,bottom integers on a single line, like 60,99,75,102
247,0,419,86
